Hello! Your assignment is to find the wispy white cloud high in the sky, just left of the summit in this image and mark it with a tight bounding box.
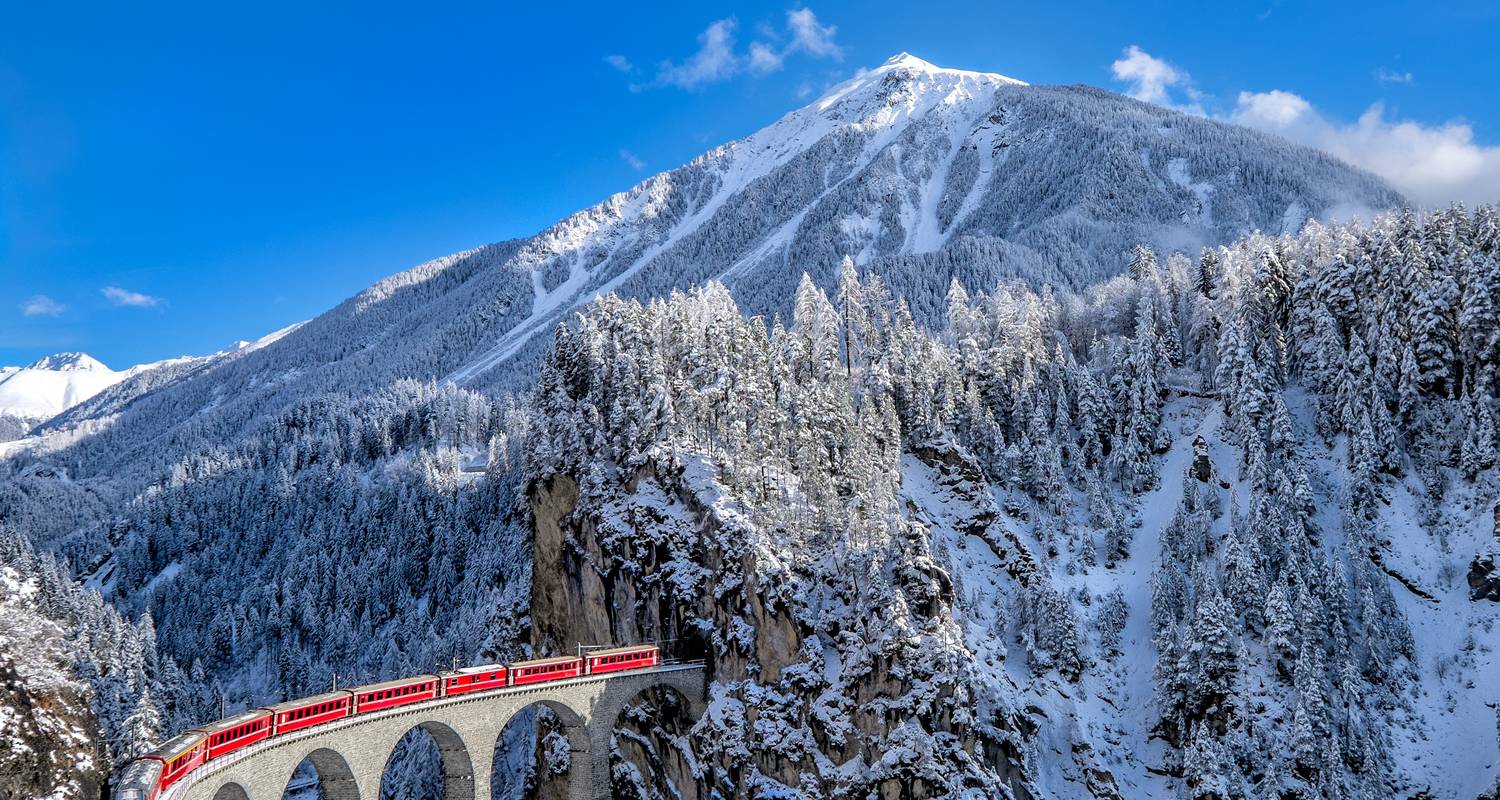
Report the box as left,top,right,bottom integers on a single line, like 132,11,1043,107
633,8,843,92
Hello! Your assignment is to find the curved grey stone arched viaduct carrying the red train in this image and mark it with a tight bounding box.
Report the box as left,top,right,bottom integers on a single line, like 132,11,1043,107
161,663,705,800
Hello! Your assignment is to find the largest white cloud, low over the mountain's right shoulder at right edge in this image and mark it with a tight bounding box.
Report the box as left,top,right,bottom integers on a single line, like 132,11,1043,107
1229,90,1500,207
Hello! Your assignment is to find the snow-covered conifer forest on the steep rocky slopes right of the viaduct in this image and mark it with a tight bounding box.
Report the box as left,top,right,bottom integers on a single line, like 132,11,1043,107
528,209,1500,798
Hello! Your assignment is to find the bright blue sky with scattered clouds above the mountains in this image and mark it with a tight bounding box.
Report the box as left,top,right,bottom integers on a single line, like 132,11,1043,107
0,0,1500,368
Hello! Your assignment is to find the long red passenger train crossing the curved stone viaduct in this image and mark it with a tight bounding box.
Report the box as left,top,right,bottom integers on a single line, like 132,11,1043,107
114,644,662,800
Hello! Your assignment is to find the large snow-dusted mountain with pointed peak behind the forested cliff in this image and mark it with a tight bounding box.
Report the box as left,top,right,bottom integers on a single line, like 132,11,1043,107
26,54,1401,474
